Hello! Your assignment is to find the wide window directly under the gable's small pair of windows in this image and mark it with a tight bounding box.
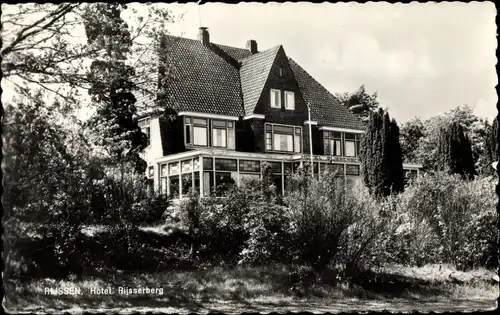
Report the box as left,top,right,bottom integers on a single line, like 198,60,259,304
265,124,302,153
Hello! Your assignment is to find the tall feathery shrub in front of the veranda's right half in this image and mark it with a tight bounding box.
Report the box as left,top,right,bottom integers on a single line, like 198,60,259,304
285,172,358,271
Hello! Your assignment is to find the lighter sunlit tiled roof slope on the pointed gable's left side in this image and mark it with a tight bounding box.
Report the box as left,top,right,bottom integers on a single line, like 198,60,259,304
240,46,281,115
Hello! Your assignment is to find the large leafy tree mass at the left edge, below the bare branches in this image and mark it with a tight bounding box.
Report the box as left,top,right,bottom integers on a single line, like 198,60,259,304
2,93,93,275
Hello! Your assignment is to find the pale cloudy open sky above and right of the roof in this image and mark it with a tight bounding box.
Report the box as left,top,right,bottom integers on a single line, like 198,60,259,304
164,2,498,122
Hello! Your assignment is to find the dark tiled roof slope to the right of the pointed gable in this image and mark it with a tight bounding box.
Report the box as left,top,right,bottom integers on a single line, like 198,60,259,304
288,58,365,130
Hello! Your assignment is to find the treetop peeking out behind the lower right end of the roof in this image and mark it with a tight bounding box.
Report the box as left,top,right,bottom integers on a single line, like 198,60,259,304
335,85,379,122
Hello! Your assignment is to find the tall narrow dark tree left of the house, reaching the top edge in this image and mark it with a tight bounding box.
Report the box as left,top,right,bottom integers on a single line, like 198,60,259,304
85,3,147,173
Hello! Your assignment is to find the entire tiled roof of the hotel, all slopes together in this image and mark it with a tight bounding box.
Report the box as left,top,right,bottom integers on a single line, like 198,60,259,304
144,32,365,130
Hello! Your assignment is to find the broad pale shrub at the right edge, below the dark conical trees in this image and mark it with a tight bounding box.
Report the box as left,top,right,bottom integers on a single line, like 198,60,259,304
385,173,497,269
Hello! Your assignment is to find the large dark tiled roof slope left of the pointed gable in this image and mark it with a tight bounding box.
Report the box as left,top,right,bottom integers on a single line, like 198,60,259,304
157,36,244,116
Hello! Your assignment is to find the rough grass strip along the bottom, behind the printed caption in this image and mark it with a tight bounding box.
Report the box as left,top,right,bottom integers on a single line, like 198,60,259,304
4,266,499,313
